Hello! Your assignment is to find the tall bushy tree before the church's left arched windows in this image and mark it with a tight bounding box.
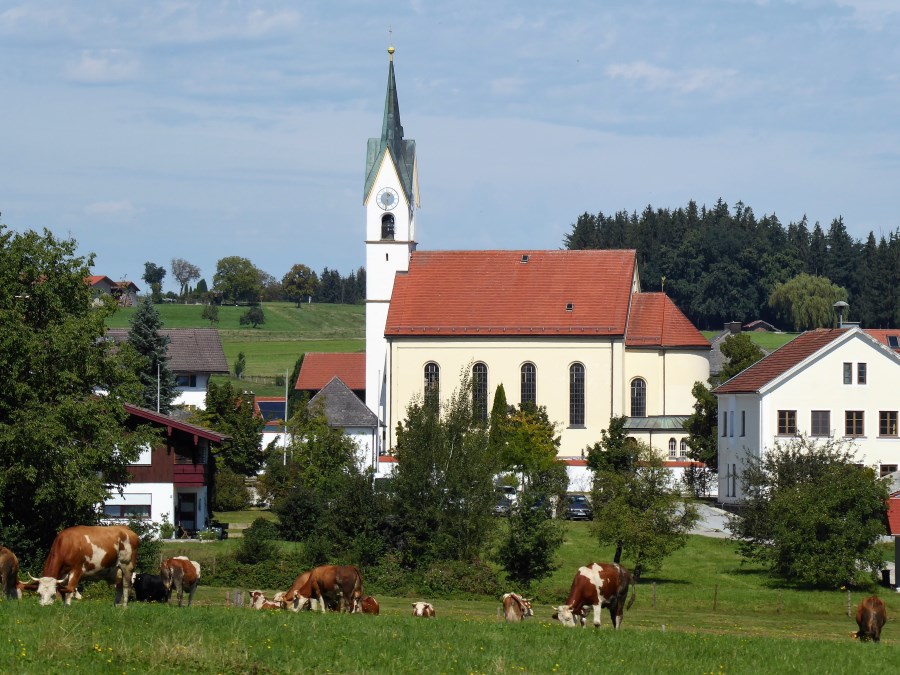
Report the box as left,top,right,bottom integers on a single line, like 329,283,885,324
391,369,498,567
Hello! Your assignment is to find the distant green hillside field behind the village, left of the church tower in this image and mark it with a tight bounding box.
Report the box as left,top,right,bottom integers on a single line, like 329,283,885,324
107,302,366,396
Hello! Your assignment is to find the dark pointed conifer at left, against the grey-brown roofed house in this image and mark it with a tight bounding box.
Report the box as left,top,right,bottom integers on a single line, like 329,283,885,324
128,298,178,413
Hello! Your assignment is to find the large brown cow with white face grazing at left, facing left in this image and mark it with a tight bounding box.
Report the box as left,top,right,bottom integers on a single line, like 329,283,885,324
28,525,139,606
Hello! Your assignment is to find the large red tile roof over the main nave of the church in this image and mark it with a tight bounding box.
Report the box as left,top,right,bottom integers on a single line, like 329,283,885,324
385,250,635,336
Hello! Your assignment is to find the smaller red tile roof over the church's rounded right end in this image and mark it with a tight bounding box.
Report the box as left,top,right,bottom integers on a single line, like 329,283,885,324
625,293,709,349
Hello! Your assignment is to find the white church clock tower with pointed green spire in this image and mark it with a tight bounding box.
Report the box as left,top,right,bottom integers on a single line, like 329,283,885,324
363,46,419,438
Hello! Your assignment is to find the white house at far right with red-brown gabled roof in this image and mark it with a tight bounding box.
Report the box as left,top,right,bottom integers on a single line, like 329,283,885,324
713,326,900,503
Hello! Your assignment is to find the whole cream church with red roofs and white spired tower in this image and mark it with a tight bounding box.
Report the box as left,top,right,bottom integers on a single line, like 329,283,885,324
316,47,710,476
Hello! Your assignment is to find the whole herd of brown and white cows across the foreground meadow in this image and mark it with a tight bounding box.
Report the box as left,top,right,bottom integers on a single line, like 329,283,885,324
0,525,887,642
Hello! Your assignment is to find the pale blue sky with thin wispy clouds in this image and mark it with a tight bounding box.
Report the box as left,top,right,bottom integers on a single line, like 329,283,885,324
0,0,900,290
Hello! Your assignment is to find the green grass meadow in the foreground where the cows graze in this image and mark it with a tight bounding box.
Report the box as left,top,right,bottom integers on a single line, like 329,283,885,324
0,524,900,674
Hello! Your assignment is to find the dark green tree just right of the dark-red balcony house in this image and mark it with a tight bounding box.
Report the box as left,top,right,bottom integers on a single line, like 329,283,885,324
195,381,266,476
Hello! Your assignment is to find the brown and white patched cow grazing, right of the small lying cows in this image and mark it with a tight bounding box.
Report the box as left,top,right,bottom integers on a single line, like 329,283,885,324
553,563,635,628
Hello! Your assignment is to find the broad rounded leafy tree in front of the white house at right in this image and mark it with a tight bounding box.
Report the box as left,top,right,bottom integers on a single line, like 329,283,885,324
728,437,888,588
